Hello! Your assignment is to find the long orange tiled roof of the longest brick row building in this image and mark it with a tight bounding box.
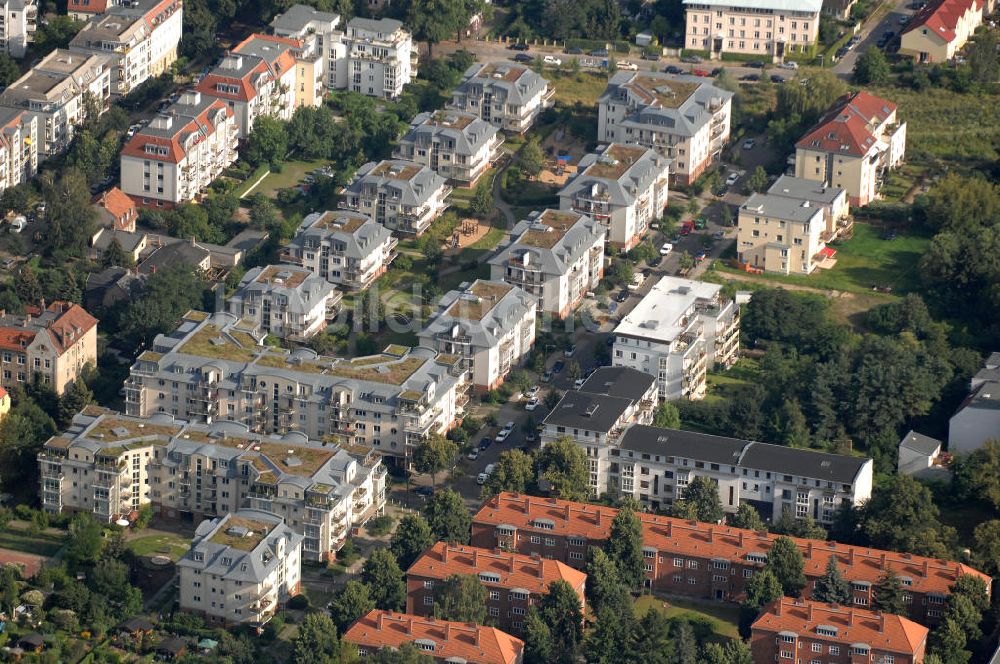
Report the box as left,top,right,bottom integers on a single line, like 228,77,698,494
473,493,991,595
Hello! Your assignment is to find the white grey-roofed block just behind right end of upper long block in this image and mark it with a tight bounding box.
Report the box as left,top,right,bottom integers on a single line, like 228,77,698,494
420,279,536,391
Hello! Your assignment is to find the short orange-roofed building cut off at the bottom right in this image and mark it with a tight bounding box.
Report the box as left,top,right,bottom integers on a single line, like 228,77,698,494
750,597,928,664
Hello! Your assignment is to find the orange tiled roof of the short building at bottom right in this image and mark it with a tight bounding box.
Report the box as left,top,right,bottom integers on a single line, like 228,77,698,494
753,597,928,657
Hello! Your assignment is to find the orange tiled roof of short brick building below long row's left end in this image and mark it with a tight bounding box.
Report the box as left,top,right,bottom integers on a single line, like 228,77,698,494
406,542,587,594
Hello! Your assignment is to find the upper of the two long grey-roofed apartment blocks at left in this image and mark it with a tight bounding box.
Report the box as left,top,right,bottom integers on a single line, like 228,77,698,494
125,311,468,461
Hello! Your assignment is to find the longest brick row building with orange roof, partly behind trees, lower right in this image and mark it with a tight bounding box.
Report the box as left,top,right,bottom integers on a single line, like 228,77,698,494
472,493,990,622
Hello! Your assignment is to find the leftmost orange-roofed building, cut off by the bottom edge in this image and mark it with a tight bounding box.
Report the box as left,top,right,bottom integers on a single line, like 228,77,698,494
341,610,524,664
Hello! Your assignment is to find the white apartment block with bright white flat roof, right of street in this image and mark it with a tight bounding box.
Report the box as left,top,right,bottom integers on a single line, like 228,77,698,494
611,276,740,401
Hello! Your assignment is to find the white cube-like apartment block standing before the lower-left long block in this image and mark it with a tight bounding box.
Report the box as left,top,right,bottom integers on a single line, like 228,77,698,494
177,510,303,628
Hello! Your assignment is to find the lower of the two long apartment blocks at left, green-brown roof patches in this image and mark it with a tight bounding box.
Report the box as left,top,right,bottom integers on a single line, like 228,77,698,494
38,406,386,561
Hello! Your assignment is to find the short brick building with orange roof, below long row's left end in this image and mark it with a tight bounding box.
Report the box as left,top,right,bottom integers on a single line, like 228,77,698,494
406,542,587,634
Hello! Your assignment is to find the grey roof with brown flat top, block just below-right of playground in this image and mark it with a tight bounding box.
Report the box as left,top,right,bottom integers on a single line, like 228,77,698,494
559,144,671,207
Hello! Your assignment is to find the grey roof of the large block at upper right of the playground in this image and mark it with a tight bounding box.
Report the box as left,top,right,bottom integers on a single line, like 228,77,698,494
597,71,733,136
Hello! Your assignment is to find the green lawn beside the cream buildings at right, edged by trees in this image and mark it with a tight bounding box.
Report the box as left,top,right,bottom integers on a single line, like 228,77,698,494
716,223,930,295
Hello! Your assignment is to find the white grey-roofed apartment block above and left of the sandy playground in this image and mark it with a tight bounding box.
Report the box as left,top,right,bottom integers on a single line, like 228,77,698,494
451,62,555,134
